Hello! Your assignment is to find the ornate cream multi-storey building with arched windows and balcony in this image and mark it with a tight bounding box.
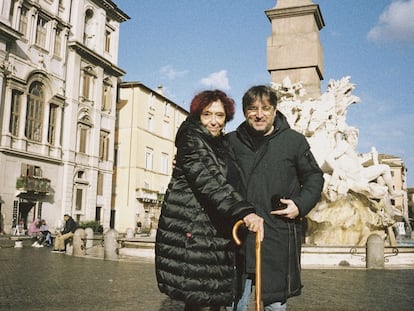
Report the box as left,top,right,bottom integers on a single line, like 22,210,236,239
0,0,129,233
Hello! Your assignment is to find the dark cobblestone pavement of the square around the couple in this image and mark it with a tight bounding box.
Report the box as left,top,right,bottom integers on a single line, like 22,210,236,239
0,241,414,311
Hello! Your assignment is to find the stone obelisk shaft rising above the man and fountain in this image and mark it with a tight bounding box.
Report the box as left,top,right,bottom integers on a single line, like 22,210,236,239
265,0,325,99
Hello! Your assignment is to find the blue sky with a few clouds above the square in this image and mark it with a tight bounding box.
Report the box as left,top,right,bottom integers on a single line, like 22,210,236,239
115,0,414,187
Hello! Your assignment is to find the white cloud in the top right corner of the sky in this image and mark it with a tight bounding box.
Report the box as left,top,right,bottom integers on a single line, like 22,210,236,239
367,0,414,43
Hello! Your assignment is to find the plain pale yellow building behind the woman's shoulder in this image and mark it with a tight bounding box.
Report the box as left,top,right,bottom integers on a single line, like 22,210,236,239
112,82,188,232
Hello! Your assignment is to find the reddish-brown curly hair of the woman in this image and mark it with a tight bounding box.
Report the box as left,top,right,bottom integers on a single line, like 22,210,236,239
190,90,234,122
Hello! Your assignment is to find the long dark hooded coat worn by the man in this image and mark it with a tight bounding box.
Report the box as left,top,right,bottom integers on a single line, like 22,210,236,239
227,112,324,305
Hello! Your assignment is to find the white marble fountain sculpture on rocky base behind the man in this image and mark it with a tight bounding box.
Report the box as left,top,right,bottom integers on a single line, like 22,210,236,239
272,76,404,245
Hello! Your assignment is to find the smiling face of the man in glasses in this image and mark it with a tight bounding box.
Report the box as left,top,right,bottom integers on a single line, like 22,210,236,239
244,100,276,136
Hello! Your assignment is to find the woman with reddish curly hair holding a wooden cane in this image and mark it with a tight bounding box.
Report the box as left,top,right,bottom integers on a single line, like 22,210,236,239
155,90,263,311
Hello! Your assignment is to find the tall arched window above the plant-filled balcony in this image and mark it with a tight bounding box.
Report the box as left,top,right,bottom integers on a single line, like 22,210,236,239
25,82,45,142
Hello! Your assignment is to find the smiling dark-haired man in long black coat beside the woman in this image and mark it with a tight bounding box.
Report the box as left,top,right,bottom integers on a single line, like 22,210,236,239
228,85,324,311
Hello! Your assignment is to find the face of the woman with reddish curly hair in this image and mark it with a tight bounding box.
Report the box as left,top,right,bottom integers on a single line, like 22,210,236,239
200,100,226,136
